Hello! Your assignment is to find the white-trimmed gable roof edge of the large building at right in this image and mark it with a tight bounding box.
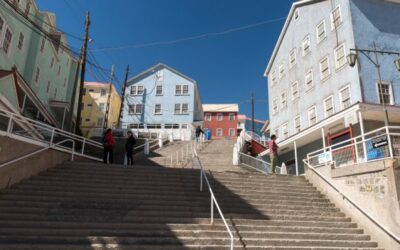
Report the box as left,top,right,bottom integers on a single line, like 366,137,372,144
264,0,326,77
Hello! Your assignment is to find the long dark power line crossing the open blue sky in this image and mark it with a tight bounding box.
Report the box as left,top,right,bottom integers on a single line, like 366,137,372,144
91,17,286,52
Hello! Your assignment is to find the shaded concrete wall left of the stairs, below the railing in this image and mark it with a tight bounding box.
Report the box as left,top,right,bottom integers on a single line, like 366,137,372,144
0,136,75,190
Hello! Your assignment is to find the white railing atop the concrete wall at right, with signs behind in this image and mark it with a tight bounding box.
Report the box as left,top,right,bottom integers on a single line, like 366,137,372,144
307,126,400,168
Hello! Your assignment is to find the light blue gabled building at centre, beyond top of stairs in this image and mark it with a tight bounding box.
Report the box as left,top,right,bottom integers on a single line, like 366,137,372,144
122,63,203,140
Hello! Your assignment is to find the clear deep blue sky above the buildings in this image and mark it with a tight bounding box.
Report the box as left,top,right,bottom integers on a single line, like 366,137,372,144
37,0,293,120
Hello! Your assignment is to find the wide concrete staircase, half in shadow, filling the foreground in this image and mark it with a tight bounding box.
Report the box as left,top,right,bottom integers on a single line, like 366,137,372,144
0,141,377,250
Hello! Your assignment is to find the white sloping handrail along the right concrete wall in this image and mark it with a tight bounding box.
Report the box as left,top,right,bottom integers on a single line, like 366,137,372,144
303,159,400,243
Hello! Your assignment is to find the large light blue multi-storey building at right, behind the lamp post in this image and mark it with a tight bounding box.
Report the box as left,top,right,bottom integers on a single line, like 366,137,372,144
265,0,400,173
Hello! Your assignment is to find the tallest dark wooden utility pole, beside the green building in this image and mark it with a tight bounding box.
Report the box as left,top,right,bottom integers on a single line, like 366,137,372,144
75,11,90,135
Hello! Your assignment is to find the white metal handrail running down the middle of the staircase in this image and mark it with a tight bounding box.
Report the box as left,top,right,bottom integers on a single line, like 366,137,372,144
193,149,234,250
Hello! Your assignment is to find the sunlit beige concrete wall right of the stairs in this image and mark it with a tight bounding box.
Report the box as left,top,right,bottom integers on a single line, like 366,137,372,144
306,160,400,249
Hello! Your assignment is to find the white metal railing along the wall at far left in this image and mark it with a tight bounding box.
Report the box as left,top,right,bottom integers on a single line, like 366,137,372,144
0,110,103,161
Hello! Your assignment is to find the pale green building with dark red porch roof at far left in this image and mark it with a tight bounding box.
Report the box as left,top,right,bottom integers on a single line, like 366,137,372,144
0,0,80,130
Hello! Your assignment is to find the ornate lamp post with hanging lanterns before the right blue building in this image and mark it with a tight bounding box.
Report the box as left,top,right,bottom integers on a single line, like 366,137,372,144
347,43,400,126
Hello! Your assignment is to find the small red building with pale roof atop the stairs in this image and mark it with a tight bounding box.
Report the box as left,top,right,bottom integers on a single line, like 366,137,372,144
203,104,239,139
